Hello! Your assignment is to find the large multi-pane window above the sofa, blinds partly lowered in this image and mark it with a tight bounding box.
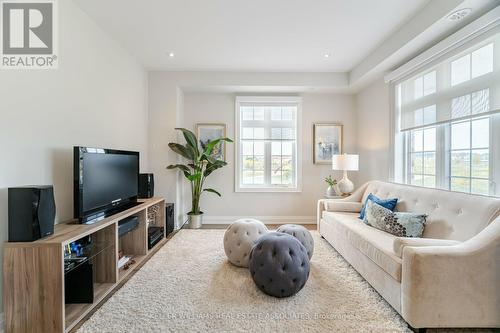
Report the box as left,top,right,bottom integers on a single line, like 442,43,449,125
393,32,500,196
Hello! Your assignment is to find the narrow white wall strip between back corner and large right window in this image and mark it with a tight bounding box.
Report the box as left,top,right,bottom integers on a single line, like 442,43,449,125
355,78,391,184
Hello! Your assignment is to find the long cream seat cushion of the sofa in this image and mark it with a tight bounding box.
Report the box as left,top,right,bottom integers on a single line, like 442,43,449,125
323,211,401,281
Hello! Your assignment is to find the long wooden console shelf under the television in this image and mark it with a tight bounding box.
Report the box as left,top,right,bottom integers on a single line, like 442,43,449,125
3,198,166,332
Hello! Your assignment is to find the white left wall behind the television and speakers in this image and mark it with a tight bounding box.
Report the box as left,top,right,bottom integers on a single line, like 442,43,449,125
0,0,148,312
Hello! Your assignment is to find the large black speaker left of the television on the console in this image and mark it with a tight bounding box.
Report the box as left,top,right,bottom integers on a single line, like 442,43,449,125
8,185,56,242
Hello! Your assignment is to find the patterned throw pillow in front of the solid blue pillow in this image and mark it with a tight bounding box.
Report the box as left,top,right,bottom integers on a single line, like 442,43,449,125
363,201,427,237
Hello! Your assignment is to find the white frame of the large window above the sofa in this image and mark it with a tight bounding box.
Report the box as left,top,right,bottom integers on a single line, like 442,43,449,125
385,14,500,197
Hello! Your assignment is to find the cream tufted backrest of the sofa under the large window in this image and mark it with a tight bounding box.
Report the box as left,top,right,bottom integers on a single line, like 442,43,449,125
361,181,500,241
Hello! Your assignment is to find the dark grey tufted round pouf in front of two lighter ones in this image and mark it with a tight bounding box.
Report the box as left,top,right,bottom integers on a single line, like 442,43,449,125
249,232,309,297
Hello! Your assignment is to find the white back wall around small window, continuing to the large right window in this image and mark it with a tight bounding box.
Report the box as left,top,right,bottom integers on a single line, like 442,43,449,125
149,71,390,225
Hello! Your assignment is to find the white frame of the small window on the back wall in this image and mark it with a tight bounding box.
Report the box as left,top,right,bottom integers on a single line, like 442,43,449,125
234,96,302,192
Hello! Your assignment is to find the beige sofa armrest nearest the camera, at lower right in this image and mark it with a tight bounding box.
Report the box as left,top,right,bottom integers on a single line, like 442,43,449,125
401,218,500,328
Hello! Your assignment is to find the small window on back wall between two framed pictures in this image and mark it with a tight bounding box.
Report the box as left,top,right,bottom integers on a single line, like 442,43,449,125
235,97,301,192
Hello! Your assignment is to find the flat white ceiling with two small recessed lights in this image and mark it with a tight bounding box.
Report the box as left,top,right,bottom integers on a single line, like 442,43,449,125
75,0,429,72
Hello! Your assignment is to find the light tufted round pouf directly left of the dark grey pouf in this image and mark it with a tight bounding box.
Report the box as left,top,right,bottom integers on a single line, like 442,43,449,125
224,219,268,267
